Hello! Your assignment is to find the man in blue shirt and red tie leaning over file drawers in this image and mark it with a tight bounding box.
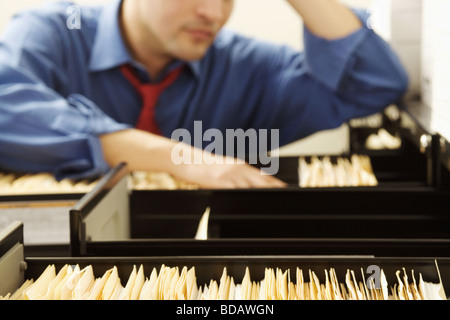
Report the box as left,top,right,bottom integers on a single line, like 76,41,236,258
0,0,407,188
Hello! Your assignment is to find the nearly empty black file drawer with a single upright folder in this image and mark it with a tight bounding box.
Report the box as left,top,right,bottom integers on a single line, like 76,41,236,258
70,159,450,257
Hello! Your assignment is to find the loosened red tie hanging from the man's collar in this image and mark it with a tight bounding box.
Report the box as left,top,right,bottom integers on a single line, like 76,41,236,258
121,65,182,135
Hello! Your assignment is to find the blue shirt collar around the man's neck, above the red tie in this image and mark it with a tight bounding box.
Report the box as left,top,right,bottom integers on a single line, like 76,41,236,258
89,0,201,77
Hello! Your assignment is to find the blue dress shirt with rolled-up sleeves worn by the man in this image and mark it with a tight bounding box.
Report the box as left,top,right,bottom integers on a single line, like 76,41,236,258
0,0,408,179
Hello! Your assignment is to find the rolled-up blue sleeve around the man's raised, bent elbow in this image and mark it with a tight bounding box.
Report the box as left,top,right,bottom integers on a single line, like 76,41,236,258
304,9,408,101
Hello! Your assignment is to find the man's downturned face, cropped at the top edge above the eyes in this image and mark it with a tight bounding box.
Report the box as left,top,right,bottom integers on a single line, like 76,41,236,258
139,0,234,61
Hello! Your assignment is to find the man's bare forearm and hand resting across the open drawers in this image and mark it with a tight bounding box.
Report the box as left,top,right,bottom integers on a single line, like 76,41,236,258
100,129,286,189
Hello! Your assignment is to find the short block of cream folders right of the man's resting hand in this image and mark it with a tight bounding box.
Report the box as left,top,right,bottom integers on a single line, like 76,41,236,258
298,155,378,188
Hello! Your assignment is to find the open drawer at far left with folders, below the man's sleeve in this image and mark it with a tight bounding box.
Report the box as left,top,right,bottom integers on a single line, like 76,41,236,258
0,170,95,245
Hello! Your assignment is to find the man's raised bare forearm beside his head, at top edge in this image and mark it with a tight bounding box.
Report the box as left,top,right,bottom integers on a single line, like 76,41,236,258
287,0,362,40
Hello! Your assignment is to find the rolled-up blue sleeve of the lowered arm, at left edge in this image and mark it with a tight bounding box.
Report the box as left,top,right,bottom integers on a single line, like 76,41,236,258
0,10,127,179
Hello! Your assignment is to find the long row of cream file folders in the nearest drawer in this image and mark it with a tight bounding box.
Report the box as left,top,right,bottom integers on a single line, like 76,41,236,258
0,265,446,300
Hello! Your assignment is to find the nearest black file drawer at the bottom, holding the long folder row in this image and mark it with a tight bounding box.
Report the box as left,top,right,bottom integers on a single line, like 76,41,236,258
0,222,450,299
